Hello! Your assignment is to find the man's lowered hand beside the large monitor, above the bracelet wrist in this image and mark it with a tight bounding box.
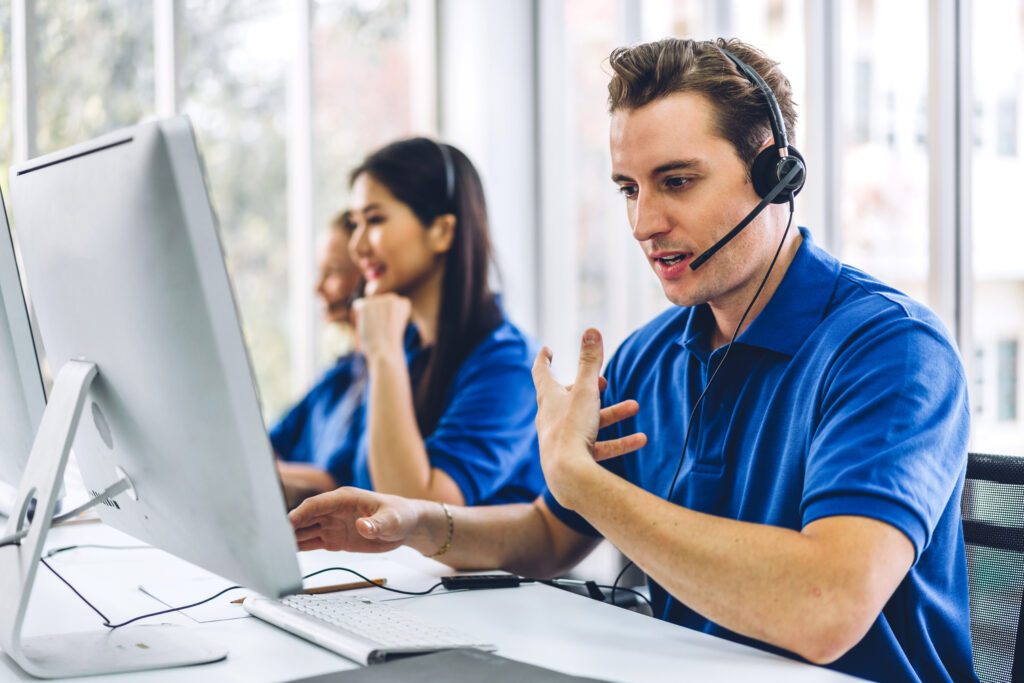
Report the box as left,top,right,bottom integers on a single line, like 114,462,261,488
288,486,428,553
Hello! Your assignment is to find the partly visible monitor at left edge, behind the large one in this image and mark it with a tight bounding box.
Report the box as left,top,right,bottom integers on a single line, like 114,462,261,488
0,189,46,517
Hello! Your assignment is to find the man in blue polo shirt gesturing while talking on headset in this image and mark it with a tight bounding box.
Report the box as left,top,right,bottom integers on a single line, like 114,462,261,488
292,40,975,681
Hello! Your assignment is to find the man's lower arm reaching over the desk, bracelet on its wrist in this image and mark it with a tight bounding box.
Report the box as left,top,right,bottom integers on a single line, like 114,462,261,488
290,487,597,578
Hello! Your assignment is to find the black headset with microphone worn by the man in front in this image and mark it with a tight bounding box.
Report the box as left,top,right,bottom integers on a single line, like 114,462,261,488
690,47,807,270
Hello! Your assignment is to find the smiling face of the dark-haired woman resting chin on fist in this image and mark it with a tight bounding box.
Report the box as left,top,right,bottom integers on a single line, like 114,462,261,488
349,173,451,297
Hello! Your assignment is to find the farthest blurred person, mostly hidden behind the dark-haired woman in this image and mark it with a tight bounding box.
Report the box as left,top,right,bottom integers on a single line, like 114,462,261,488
270,213,365,508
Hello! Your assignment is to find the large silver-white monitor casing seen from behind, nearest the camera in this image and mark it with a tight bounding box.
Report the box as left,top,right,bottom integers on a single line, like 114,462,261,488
0,117,302,667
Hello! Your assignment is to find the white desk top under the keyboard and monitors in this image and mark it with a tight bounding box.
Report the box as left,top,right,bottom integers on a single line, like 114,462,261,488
0,522,853,683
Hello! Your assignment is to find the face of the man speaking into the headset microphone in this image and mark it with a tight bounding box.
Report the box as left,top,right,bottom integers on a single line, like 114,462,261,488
611,92,777,306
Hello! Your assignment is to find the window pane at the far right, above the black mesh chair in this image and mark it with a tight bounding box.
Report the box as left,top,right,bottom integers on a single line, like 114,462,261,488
968,0,1024,455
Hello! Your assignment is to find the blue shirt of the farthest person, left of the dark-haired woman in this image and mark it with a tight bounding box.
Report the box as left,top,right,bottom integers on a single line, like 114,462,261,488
270,354,366,485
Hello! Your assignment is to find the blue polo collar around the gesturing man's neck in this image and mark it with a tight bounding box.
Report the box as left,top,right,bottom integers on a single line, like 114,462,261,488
679,227,842,362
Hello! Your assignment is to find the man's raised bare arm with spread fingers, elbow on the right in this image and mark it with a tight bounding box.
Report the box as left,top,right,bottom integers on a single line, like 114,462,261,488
534,330,914,663
